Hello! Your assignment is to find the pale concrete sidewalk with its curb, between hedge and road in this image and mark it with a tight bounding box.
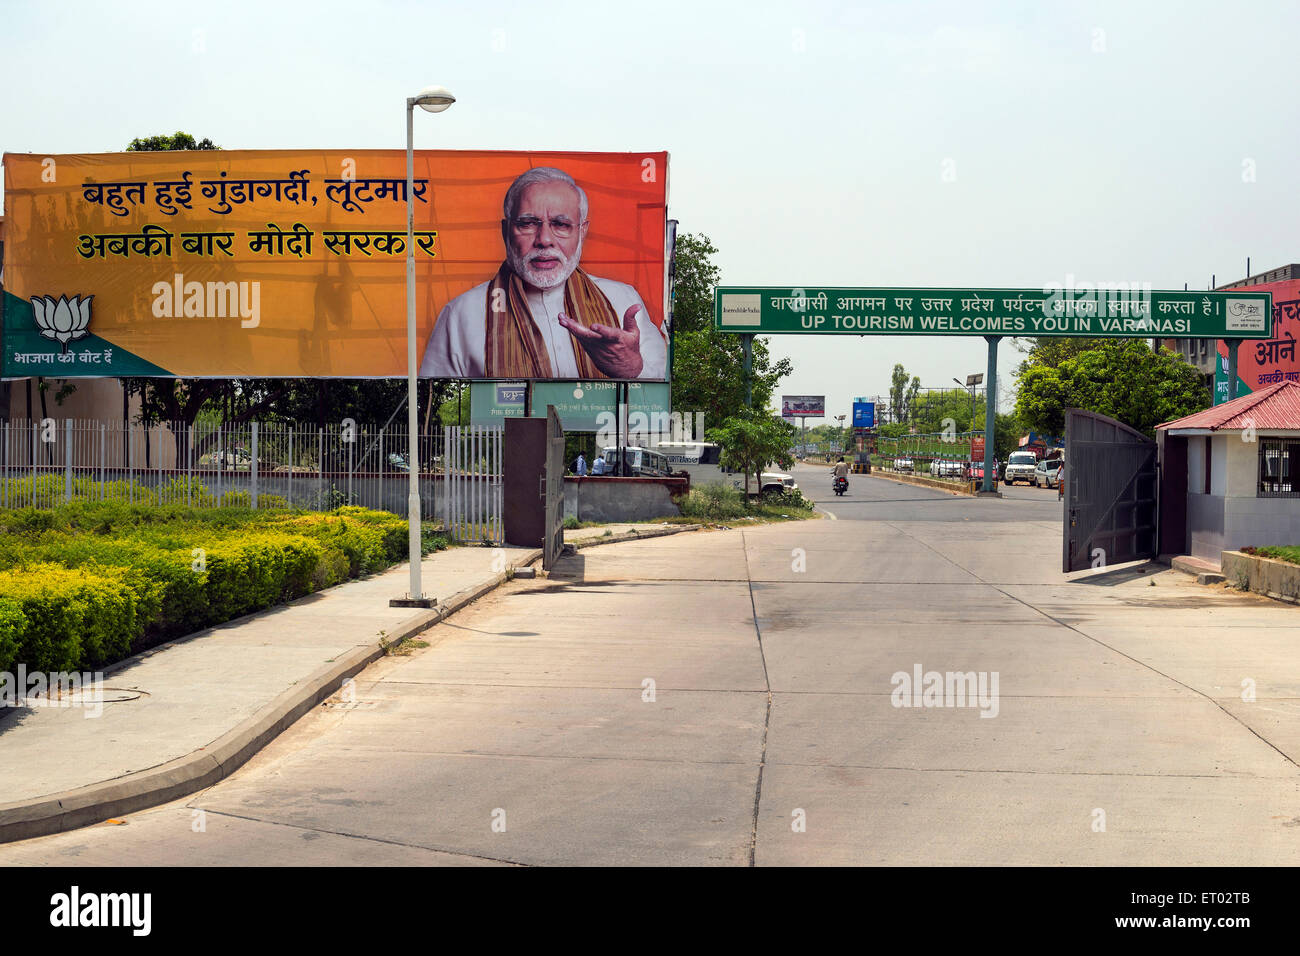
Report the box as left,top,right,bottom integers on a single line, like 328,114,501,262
0,522,696,843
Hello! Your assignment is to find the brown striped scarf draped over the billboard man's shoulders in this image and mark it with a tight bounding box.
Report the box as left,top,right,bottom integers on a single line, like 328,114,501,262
484,263,621,380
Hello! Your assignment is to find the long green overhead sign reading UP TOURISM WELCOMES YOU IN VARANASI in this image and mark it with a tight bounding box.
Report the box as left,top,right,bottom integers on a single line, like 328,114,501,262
714,286,1273,338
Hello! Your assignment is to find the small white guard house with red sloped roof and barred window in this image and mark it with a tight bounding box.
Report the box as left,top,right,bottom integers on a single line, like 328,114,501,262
1156,381,1300,564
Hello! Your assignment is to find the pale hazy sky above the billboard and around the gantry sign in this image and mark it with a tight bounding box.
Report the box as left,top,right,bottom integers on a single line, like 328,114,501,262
0,0,1300,424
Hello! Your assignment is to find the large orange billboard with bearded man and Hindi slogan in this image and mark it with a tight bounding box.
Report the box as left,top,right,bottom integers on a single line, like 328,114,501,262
3,150,668,381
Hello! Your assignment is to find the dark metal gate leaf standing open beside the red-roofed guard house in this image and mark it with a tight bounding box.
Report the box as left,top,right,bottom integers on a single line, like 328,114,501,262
1062,408,1157,571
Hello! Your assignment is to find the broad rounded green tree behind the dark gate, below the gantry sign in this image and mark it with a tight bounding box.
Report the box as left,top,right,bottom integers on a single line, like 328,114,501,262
1015,339,1210,436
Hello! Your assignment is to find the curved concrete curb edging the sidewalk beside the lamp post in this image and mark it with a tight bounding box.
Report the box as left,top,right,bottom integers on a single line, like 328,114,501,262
0,549,542,843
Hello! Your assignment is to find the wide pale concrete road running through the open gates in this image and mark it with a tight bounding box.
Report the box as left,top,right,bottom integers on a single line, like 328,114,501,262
0,468,1300,865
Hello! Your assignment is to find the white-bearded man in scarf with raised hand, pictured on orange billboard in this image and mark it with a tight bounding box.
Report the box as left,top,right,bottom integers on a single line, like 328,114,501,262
420,166,668,380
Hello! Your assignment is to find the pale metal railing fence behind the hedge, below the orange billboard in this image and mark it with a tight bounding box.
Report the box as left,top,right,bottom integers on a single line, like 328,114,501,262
0,419,503,542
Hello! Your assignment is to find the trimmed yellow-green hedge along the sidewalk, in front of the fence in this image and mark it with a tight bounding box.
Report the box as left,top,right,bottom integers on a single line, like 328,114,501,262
0,502,446,671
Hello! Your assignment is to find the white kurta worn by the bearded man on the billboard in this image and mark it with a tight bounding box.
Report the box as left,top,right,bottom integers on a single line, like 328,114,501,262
420,276,668,380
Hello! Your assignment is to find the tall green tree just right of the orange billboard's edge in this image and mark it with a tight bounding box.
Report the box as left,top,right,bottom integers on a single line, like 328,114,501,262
672,234,794,423
